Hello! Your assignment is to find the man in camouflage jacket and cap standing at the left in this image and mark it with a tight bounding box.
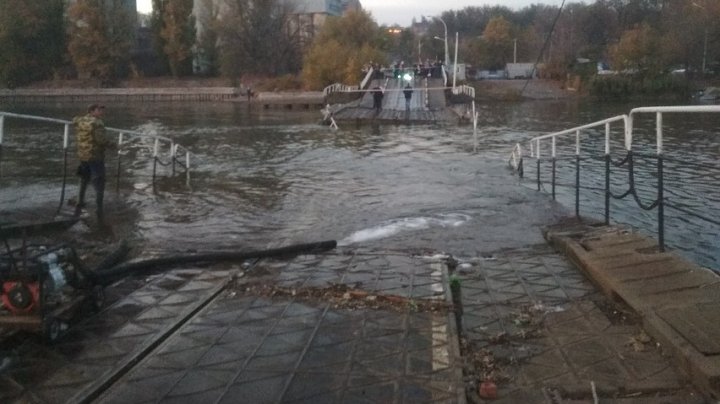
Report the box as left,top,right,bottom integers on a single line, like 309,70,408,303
73,104,112,226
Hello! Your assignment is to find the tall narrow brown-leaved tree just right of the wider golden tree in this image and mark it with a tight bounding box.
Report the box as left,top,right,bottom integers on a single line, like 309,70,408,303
160,0,195,77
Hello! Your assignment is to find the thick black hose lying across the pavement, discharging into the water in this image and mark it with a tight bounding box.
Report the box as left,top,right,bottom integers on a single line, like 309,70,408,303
92,240,337,286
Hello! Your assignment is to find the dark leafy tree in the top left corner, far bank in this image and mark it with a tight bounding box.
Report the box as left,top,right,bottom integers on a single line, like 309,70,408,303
0,0,65,87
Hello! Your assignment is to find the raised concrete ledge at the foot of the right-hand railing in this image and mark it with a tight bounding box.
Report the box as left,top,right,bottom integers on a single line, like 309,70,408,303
546,223,720,397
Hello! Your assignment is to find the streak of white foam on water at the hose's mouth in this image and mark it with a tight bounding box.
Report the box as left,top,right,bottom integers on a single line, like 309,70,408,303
338,213,470,246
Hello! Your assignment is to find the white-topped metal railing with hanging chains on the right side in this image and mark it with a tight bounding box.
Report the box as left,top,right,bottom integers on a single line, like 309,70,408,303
508,105,720,251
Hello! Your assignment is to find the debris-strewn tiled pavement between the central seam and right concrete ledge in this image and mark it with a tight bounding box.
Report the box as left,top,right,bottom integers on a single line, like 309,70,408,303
457,245,704,403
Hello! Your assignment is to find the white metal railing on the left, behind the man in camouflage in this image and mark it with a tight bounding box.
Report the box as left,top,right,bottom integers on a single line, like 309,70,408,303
0,111,190,211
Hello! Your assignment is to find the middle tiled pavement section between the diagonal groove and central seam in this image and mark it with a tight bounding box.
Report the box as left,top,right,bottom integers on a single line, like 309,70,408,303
95,254,464,403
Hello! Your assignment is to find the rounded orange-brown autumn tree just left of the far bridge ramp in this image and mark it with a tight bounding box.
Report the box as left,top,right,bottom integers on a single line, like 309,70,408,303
302,11,386,89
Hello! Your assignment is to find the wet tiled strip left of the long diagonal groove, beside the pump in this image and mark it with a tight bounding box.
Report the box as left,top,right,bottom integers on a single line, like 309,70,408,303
0,269,228,403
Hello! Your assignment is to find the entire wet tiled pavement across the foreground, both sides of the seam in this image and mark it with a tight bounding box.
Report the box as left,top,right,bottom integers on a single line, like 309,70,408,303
0,245,704,403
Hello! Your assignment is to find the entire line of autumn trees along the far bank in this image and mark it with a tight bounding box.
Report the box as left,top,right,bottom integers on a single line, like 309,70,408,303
0,0,720,89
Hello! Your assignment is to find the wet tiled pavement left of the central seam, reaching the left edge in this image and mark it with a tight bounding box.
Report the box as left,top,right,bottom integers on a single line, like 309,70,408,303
0,252,464,403
